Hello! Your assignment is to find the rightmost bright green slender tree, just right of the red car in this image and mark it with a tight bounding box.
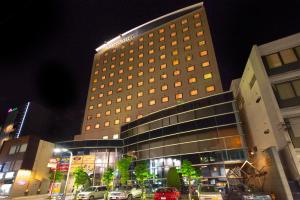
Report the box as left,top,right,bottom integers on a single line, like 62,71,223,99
178,160,200,199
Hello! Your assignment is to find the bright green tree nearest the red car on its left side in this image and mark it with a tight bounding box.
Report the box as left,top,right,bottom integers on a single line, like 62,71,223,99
134,162,154,199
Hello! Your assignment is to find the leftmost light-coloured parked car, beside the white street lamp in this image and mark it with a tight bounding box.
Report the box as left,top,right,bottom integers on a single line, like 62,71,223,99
76,186,107,200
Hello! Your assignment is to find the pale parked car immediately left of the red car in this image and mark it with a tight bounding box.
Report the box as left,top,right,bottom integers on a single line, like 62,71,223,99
108,186,142,200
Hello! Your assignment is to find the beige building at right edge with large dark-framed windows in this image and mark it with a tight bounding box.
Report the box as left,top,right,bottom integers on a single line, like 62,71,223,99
231,33,300,199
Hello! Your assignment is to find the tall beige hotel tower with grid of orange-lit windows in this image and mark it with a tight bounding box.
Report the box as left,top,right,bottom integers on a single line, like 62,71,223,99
75,3,222,140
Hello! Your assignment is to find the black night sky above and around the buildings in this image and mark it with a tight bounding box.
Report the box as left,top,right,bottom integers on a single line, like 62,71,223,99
0,0,300,141
